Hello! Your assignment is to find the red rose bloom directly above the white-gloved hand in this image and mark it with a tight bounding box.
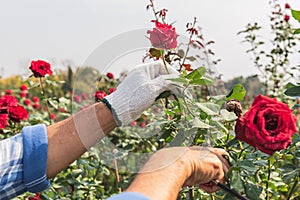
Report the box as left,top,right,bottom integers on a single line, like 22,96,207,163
147,21,178,49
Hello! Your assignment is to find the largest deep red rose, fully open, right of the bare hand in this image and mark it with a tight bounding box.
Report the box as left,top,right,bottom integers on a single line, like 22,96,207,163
235,95,297,155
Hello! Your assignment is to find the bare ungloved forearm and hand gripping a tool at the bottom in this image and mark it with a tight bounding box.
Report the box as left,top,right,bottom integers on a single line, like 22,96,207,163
112,147,229,200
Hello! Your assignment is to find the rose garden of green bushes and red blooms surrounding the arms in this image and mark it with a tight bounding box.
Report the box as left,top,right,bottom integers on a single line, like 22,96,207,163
0,0,300,200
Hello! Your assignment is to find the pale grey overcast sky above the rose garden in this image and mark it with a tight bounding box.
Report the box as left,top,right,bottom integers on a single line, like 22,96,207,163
0,0,300,79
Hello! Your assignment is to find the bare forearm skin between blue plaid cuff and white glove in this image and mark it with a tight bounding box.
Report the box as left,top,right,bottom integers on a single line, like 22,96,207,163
46,103,116,178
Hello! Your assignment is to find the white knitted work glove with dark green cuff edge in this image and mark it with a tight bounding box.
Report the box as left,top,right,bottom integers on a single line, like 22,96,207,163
105,61,179,126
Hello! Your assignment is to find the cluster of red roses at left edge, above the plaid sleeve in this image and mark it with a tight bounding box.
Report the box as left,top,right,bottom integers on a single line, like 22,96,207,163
0,95,28,128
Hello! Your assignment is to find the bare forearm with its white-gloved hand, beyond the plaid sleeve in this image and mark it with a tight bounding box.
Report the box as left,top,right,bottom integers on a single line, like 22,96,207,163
47,62,178,178
